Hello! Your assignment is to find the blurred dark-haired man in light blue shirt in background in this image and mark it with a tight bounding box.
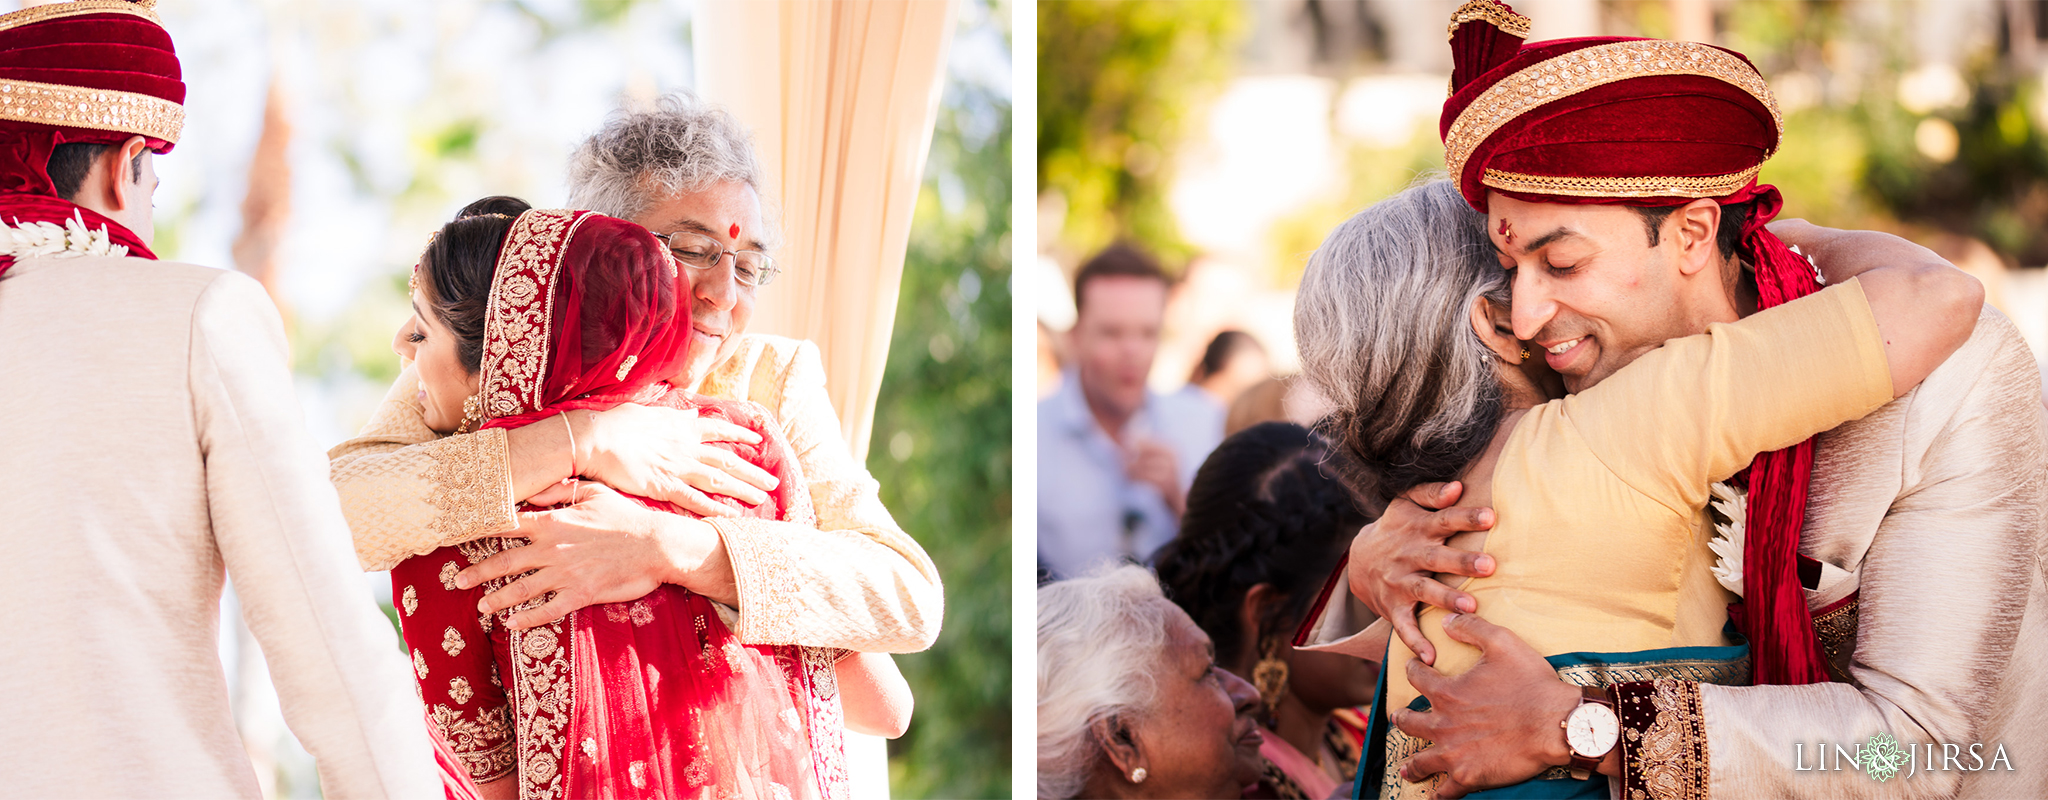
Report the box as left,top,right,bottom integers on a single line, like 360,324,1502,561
1038,246,1217,579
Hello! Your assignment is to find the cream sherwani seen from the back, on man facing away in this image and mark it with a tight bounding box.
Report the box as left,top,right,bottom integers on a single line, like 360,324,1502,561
0,256,442,798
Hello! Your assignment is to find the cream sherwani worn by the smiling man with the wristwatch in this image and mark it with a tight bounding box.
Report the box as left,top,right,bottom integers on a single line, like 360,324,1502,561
1671,307,2048,798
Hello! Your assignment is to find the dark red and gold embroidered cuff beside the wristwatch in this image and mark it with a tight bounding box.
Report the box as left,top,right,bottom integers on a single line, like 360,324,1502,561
1612,679,1708,800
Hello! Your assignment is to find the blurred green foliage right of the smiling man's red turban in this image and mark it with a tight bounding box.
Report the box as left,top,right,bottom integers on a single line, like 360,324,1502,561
1720,0,2048,266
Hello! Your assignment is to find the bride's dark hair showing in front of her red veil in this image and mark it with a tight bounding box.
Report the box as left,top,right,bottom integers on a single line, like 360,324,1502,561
420,194,532,372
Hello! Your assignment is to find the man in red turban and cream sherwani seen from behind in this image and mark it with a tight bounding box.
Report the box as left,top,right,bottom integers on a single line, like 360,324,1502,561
0,0,442,798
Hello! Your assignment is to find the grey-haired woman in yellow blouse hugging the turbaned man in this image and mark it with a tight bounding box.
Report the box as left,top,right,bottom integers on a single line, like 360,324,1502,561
1294,180,1982,798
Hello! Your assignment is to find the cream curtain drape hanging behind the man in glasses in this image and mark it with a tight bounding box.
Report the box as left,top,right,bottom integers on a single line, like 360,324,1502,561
692,0,952,458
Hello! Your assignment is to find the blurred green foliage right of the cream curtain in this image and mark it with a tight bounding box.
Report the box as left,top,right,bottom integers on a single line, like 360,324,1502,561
868,0,1012,798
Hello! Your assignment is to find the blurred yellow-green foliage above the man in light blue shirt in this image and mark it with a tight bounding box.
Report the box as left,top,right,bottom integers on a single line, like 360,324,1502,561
1038,0,1247,262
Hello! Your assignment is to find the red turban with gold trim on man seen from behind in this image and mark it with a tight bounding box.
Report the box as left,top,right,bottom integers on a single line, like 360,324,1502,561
0,0,184,270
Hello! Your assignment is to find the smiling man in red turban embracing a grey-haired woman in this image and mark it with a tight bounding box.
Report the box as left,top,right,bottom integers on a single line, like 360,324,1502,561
1354,0,2048,798
